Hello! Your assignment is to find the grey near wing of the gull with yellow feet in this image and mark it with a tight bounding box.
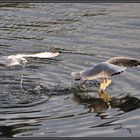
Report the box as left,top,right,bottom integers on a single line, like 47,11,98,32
80,62,126,80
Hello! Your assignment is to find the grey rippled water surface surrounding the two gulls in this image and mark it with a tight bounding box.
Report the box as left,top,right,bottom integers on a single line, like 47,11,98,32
0,3,140,137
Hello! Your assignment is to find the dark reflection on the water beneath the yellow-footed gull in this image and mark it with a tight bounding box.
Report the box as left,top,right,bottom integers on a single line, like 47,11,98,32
72,92,140,113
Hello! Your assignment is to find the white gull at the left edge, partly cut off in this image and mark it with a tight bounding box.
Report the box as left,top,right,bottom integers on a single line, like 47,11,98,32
0,52,59,66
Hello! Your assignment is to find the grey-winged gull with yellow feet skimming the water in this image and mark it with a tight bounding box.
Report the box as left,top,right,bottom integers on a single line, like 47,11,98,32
71,57,140,96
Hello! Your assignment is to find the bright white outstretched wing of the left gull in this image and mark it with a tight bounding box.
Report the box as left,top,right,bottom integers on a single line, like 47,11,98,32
16,52,59,58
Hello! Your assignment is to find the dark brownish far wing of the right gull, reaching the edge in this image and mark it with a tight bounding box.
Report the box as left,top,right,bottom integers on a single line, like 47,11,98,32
107,57,140,67
